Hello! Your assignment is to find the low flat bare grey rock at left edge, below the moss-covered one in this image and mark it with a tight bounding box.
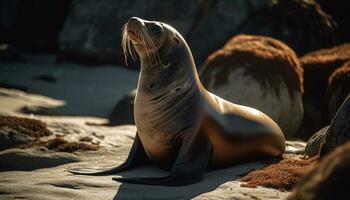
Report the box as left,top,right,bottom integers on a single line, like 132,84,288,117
0,147,80,171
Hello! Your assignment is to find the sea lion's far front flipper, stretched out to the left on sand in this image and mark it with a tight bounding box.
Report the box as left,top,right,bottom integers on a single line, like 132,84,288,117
67,133,150,175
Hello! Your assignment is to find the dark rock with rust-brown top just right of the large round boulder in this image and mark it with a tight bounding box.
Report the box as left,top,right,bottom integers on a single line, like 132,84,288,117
299,43,350,139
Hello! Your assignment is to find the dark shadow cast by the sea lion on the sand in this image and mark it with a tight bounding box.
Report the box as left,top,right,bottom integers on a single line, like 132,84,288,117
113,162,266,199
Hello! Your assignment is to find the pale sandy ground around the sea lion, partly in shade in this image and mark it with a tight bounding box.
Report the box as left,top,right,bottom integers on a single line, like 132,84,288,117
0,59,305,199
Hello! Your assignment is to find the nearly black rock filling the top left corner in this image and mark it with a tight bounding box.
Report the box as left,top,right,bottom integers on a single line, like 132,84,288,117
0,0,70,52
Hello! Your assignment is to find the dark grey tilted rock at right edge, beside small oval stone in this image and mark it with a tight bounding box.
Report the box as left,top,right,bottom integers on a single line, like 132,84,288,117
320,94,350,156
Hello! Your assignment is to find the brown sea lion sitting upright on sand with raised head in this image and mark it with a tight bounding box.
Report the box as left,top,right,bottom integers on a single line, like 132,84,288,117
69,17,285,186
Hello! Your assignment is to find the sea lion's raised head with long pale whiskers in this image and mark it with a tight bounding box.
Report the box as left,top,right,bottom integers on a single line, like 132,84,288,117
122,17,192,68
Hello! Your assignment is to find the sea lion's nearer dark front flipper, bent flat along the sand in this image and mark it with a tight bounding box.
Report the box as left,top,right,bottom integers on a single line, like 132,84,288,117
113,136,212,186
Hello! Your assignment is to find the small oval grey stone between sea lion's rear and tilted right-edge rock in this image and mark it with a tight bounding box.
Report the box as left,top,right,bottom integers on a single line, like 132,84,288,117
305,126,329,157
